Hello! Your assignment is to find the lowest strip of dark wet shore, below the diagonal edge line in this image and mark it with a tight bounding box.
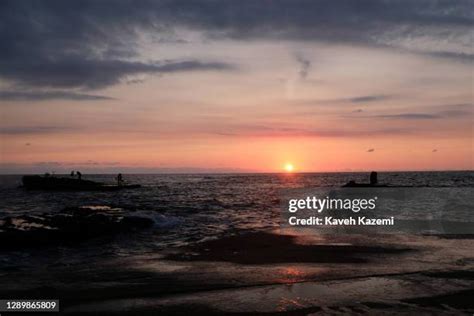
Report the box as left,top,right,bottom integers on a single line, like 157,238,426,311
64,273,474,315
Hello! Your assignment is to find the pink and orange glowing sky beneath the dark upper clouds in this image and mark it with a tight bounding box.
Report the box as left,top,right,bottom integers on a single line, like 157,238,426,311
0,1,473,173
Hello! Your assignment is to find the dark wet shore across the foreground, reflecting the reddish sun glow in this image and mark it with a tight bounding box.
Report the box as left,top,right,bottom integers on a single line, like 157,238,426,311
0,230,474,315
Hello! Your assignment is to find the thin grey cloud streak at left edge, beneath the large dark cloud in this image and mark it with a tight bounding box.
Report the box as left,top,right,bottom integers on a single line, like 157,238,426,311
0,91,113,101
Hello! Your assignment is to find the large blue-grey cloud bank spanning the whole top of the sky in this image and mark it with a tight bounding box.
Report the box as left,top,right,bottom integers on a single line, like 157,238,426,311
0,0,473,88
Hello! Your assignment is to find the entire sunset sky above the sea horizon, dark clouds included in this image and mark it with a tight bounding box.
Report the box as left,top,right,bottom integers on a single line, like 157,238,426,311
0,0,474,173
